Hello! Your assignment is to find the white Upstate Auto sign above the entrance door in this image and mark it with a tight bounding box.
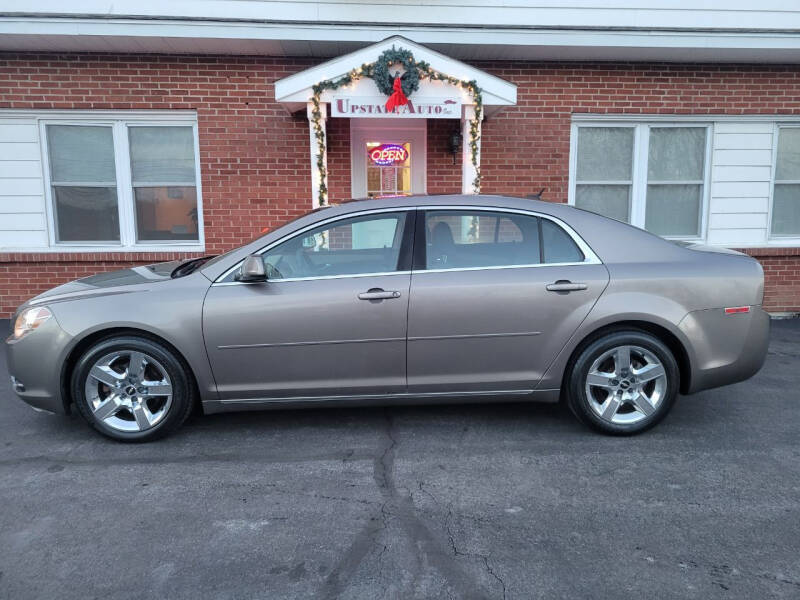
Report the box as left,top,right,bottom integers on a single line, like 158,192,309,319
331,96,461,119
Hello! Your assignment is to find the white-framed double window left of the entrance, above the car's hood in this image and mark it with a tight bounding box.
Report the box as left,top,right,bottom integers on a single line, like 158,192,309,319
43,118,202,248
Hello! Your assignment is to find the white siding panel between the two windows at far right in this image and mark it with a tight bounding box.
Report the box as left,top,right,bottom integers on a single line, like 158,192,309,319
707,120,774,246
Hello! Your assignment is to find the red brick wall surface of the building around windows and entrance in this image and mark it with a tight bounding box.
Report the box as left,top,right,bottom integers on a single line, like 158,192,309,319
0,54,800,317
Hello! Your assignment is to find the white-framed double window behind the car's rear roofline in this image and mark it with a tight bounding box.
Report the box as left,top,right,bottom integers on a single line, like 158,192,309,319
571,122,709,239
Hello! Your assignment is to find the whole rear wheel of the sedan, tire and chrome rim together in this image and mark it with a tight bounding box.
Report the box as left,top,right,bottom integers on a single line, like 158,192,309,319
567,330,680,435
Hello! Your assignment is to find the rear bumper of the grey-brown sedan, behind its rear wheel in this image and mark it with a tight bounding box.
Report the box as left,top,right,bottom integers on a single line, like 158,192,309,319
678,306,769,394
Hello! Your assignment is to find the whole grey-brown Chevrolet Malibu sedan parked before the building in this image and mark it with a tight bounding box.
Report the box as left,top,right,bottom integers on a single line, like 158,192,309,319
6,196,769,442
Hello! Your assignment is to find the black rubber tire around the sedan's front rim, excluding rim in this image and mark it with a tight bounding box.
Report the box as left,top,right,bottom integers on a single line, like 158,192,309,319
70,335,195,443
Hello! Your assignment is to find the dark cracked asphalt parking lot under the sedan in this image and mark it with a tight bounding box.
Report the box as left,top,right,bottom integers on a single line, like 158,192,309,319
0,320,800,600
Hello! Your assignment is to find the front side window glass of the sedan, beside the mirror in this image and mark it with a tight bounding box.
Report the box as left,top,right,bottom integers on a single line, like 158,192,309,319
262,212,406,279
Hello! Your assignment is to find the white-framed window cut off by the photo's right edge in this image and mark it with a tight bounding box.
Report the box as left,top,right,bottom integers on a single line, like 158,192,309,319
770,127,800,237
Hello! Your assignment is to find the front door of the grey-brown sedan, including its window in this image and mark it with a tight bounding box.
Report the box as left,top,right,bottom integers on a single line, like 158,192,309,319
203,210,414,401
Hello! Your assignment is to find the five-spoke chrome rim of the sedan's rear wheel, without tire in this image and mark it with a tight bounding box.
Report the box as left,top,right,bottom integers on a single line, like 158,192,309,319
586,345,667,425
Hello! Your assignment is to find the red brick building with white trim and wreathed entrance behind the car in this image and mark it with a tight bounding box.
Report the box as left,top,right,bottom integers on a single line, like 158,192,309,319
0,2,800,318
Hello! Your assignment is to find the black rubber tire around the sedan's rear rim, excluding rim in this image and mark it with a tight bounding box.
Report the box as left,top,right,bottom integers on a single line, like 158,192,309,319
565,329,680,435
